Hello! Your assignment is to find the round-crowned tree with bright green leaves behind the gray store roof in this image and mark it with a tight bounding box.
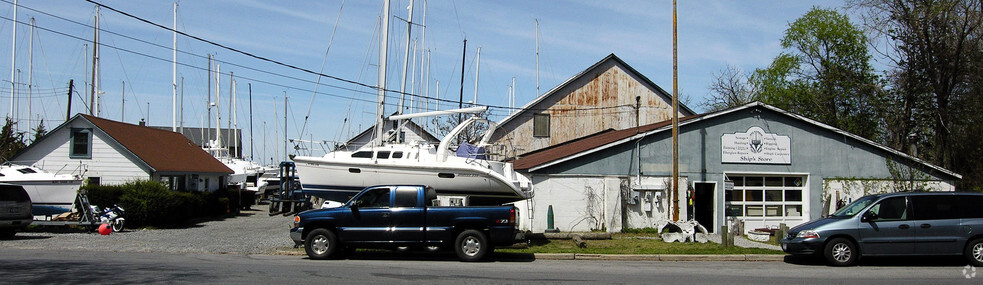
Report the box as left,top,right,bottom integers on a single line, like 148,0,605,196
750,8,883,140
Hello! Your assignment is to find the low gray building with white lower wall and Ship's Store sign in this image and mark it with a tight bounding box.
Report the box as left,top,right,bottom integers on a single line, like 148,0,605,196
515,102,961,232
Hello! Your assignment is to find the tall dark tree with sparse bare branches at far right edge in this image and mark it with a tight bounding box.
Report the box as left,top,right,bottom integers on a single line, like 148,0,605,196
849,0,983,178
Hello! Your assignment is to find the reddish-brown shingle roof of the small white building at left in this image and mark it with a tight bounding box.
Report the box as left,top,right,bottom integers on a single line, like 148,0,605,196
78,114,233,173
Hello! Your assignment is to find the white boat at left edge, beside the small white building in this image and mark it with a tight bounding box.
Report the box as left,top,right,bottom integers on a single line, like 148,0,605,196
0,163,82,216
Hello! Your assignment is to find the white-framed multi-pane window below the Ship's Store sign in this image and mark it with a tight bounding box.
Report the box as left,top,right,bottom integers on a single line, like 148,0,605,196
724,175,806,219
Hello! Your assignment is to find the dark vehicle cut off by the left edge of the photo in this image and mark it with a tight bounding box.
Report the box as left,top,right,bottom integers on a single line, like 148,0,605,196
0,183,34,238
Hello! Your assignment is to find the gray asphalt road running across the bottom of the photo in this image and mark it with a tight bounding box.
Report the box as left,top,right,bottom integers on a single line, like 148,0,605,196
0,248,983,284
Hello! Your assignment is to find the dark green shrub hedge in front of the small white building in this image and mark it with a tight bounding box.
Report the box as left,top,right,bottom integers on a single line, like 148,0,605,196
83,180,229,227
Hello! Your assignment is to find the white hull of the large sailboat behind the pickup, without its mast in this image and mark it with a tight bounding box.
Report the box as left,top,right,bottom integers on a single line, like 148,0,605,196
293,139,533,204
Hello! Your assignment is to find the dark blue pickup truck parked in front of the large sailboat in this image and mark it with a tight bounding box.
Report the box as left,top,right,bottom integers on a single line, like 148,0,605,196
290,185,525,261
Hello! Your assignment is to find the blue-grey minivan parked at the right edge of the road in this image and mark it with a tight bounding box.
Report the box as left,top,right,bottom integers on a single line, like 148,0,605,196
781,192,983,266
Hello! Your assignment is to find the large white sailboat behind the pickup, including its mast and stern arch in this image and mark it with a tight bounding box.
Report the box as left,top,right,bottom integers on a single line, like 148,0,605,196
293,0,534,205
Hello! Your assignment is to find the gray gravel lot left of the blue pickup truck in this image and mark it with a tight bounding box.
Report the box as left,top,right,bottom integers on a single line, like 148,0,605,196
0,205,294,254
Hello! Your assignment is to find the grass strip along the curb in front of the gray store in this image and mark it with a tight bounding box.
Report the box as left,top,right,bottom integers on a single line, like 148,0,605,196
495,233,784,254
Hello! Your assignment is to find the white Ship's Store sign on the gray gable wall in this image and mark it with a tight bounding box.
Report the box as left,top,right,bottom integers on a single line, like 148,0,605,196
720,127,792,164
